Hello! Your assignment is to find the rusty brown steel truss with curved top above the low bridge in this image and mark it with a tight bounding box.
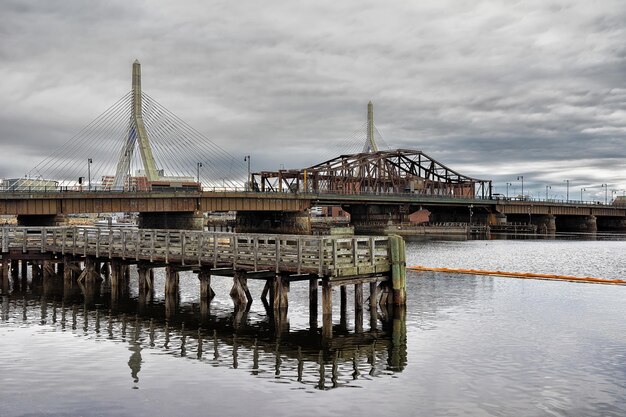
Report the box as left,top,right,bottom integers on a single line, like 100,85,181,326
252,149,491,198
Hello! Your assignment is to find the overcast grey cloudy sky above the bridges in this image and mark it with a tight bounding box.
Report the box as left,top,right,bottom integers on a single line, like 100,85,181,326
0,0,626,199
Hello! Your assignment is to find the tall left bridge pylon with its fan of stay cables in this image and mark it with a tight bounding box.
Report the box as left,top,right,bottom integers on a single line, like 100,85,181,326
19,62,247,191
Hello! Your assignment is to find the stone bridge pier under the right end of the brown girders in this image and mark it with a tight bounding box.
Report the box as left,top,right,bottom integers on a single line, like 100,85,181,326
235,211,311,235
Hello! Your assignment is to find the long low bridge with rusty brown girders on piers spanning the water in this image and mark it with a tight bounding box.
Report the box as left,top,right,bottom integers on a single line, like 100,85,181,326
0,191,626,234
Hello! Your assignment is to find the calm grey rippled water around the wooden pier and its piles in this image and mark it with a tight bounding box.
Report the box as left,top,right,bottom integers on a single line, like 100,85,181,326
0,236,626,417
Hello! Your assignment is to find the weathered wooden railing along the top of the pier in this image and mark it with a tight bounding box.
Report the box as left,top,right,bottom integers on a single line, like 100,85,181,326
1,226,390,277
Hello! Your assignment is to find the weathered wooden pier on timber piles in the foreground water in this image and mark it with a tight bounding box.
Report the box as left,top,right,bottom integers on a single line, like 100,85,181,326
0,226,406,337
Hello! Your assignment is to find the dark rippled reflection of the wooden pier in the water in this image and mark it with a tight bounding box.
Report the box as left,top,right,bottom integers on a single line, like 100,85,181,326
1,276,407,390
